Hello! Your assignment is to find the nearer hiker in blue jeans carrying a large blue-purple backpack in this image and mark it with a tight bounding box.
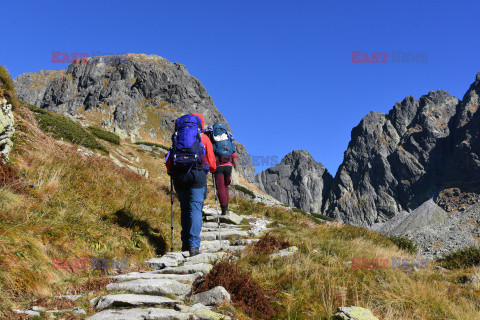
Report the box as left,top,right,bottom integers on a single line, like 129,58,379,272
165,113,217,256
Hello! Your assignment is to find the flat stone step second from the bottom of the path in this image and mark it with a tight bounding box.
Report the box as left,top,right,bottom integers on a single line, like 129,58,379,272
94,294,183,309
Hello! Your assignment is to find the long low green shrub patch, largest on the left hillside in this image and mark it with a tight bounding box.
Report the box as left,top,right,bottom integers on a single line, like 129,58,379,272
26,103,108,153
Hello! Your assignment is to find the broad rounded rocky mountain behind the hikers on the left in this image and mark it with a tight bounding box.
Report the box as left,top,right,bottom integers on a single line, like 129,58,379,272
14,54,255,181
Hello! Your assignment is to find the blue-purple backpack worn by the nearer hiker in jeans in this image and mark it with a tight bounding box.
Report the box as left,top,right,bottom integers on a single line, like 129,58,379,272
169,114,205,172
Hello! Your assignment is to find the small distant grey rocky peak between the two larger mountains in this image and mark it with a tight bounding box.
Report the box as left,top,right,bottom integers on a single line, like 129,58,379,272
255,150,333,213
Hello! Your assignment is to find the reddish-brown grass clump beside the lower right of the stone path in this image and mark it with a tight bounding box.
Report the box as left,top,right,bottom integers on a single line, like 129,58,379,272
195,261,276,319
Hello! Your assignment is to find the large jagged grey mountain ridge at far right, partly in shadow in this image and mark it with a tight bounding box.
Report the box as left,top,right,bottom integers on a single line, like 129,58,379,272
325,74,480,225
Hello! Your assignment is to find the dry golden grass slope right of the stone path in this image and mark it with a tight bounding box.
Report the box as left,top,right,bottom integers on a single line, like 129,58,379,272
232,208,480,320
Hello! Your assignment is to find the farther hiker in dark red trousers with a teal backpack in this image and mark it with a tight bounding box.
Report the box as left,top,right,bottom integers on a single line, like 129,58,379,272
206,123,237,215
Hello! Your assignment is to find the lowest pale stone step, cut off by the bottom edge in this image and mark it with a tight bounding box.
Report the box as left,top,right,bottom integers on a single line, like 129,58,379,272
86,308,191,320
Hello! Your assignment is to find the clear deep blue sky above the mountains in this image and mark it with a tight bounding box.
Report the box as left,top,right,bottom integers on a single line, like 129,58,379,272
0,0,480,174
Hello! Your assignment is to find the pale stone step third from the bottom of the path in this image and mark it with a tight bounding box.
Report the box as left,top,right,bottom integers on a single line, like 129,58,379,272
106,278,193,297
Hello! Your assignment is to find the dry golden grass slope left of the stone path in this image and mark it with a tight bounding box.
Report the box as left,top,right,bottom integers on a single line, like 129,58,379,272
0,103,186,316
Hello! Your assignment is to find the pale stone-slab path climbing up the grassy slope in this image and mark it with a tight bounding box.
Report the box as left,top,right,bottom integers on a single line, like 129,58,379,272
81,206,268,320
